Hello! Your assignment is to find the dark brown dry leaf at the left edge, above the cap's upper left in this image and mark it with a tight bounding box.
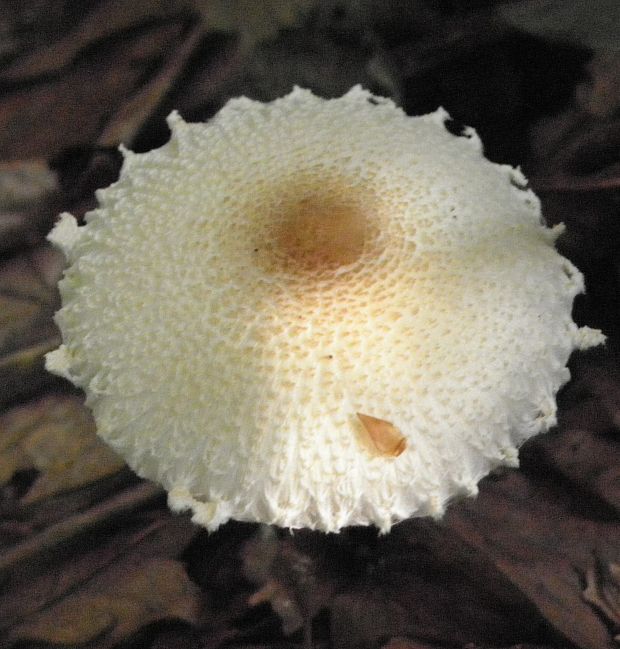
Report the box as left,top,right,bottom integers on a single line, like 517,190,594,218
0,21,184,160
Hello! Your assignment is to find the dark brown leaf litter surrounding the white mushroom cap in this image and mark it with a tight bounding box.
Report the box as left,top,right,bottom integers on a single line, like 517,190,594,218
0,0,620,649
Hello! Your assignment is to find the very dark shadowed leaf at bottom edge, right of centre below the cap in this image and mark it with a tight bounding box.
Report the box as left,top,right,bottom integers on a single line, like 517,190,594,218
327,518,556,649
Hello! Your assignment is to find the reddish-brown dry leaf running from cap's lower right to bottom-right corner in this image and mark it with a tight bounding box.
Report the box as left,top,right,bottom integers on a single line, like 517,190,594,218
446,471,620,649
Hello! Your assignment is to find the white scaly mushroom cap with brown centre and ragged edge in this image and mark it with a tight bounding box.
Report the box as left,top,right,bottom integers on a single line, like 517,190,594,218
47,87,604,531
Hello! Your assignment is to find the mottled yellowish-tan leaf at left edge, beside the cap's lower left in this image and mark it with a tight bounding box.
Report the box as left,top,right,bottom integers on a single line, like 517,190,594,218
0,395,124,503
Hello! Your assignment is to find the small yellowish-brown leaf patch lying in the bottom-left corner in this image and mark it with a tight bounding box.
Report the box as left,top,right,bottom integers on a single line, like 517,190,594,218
10,557,202,649
